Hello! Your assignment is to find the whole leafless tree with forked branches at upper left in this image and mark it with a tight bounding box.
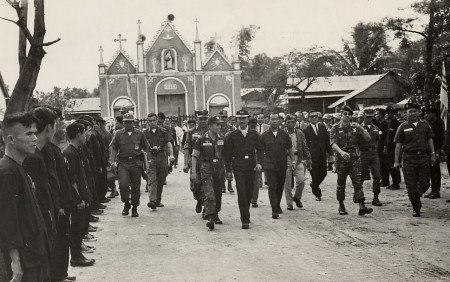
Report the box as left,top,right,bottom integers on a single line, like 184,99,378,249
0,0,61,115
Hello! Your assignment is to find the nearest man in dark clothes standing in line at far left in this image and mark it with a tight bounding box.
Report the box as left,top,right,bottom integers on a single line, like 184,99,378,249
0,113,50,282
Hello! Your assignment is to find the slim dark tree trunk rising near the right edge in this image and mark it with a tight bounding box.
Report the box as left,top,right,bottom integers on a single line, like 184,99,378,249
423,0,436,104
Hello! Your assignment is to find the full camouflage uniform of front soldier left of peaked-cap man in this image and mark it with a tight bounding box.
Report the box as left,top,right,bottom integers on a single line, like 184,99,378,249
194,132,225,216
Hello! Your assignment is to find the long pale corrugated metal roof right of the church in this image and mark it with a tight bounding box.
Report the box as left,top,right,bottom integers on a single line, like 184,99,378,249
293,73,386,93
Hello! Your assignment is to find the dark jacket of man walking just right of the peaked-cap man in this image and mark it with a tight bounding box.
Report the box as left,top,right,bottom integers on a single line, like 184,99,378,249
261,129,292,170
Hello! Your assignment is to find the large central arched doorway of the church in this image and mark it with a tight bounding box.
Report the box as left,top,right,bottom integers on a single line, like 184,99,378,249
155,77,187,116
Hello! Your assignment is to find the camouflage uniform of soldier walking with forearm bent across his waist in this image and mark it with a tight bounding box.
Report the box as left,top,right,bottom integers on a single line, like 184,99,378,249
330,122,365,203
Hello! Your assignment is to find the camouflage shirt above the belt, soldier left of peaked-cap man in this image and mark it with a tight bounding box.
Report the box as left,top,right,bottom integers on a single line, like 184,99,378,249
194,131,225,161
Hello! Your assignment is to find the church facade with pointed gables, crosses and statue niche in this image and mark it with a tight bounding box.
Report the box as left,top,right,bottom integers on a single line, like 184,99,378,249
98,16,241,119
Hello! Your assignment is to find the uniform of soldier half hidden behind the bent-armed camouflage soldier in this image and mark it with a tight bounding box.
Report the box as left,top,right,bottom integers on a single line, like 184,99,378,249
360,123,381,195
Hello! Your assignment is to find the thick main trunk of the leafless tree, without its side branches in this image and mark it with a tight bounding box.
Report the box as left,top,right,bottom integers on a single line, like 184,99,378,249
5,0,46,116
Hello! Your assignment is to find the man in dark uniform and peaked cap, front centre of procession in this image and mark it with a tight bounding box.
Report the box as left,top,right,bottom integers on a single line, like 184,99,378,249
224,110,263,229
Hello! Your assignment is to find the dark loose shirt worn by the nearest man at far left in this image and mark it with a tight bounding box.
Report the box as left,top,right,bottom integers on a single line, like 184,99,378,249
0,156,49,268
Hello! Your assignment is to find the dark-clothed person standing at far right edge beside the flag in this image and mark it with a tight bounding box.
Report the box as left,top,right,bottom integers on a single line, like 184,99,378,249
425,106,444,199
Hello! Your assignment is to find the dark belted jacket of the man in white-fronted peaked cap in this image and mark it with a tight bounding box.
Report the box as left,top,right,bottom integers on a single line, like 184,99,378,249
224,128,264,172
